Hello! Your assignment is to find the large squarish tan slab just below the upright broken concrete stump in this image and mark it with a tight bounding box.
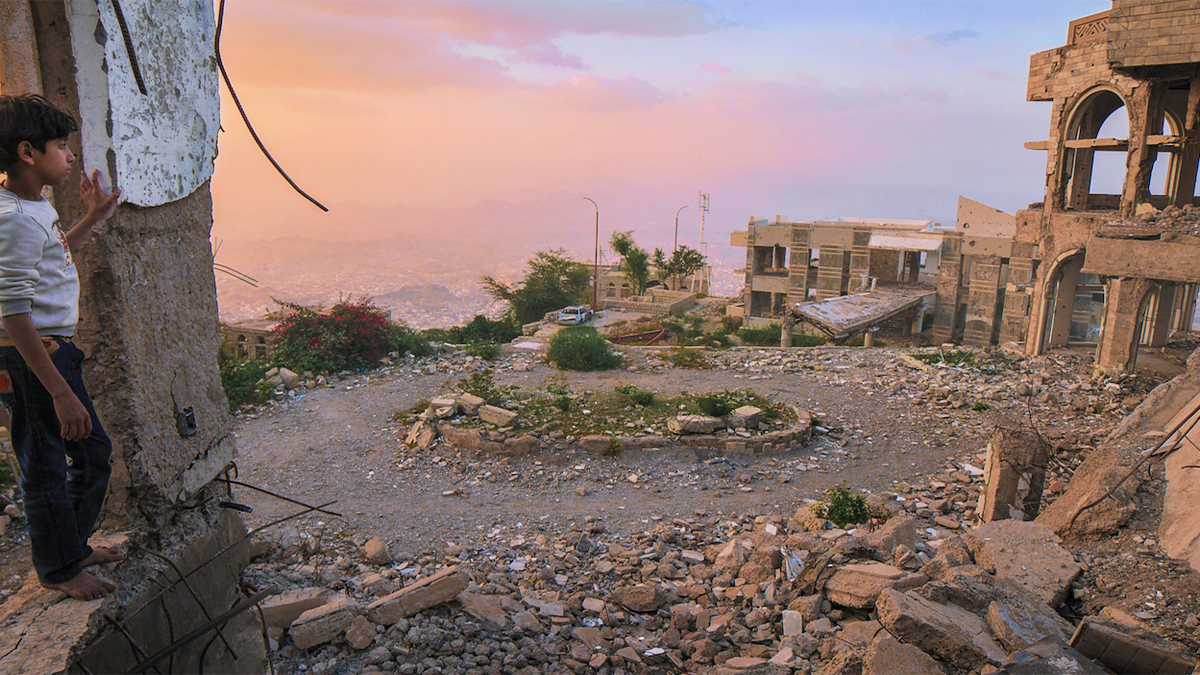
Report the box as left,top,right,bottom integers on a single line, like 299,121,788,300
966,520,1081,607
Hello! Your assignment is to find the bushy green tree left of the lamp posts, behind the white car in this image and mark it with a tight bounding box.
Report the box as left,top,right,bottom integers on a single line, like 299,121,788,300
481,249,590,323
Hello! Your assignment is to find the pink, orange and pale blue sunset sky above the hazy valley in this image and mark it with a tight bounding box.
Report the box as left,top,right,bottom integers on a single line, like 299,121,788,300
212,0,1109,269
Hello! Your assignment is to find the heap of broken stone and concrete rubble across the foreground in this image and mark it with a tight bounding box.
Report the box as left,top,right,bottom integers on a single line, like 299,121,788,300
244,473,1190,675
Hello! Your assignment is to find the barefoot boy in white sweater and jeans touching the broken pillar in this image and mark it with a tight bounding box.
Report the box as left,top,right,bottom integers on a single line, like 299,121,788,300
0,95,121,599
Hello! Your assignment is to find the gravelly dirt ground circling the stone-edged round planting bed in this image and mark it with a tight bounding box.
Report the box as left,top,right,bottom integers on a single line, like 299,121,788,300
0,336,1200,649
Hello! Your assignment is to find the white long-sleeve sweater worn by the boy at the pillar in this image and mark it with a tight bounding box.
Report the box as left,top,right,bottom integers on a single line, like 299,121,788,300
0,190,79,338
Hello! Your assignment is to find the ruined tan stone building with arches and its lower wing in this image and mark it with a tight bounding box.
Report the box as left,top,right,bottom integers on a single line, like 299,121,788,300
731,0,1200,372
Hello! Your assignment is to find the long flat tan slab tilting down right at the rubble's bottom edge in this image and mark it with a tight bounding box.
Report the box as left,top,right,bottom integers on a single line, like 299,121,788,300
875,589,1007,669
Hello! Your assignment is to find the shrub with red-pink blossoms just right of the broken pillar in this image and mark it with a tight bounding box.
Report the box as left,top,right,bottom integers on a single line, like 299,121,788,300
274,298,427,372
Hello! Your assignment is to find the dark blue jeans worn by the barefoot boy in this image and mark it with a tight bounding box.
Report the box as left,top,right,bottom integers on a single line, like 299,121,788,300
0,338,113,584
